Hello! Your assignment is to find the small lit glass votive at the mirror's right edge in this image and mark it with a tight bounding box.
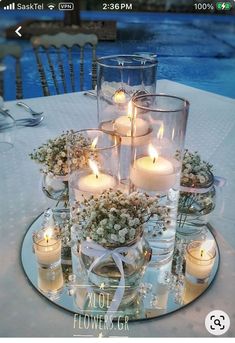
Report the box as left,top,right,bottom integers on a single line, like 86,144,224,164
185,241,216,284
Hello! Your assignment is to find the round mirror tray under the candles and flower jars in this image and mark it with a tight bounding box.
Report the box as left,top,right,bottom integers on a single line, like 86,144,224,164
21,212,219,321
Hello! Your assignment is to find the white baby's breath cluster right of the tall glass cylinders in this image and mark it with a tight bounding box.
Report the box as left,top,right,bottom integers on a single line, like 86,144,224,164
178,149,212,186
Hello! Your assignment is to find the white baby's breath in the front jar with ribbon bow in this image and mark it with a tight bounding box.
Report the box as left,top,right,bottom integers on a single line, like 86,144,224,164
73,190,169,246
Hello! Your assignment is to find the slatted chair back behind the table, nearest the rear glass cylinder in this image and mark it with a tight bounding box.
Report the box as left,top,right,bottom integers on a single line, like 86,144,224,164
31,32,98,96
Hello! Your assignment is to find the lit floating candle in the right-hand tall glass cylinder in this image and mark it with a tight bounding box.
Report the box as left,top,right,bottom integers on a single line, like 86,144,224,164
130,144,176,191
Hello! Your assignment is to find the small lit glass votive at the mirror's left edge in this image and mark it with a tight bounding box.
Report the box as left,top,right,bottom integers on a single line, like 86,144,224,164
33,228,61,268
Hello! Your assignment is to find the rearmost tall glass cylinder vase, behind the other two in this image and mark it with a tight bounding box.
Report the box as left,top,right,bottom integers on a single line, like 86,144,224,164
97,55,157,183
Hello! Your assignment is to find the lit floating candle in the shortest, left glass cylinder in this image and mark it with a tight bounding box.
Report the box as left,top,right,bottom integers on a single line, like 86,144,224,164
78,160,116,195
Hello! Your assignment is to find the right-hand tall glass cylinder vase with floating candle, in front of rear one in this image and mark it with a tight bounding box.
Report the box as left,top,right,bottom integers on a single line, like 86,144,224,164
130,94,189,264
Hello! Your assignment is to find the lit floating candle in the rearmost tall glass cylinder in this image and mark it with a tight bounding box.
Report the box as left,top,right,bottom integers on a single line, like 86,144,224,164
114,101,149,137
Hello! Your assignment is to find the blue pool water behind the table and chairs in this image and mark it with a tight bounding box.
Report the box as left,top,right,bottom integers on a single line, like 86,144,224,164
0,11,235,100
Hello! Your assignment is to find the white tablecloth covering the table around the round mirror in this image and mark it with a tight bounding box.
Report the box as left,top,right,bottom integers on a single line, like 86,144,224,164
0,80,235,337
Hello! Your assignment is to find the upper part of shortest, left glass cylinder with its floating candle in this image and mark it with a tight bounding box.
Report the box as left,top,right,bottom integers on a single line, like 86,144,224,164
68,129,121,204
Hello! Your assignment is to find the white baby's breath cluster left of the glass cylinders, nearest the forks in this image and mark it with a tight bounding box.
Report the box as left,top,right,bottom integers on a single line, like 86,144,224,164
29,130,91,176
